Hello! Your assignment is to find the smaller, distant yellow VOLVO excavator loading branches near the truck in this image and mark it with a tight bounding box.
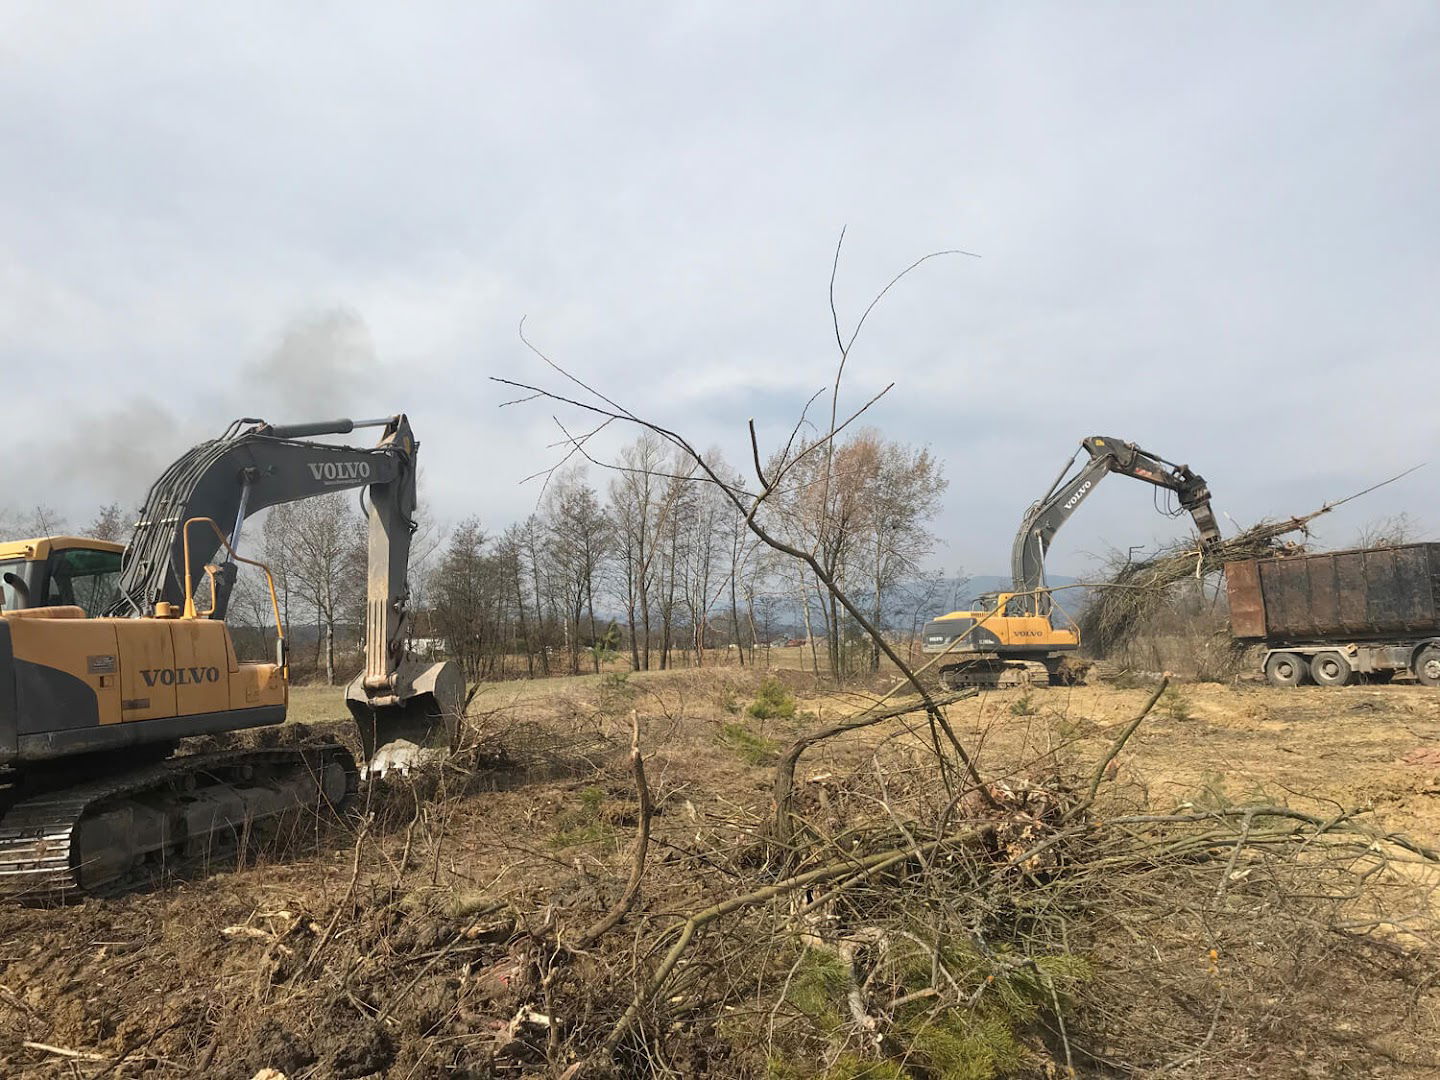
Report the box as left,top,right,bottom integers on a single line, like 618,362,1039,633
920,435,1221,690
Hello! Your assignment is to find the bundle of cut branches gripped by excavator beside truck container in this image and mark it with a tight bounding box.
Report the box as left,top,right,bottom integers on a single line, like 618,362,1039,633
1079,511,1323,657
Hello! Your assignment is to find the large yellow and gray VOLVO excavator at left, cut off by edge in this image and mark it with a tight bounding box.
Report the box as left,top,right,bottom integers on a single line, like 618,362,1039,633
0,415,464,899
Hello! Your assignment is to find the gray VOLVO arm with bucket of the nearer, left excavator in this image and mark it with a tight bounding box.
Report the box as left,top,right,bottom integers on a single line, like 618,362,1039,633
111,413,464,772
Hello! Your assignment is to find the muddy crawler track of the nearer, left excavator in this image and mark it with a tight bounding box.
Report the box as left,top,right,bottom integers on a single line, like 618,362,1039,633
0,744,360,900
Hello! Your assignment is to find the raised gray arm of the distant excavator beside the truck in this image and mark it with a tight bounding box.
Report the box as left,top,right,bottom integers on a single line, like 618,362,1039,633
1011,435,1220,606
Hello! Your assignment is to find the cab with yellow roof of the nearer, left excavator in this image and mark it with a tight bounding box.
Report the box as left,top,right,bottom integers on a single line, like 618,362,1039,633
0,536,125,618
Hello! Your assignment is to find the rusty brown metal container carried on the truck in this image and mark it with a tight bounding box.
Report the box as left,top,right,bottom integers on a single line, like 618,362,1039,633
1225,543,1440,642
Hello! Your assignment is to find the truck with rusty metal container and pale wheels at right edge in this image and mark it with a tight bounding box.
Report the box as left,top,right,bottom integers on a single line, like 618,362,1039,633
1225,543,1440,687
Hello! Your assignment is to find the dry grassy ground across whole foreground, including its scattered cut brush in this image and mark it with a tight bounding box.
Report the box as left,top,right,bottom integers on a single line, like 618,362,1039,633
0,670,1440,1080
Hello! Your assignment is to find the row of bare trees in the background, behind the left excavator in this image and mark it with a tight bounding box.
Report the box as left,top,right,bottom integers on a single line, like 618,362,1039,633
0,429,946,681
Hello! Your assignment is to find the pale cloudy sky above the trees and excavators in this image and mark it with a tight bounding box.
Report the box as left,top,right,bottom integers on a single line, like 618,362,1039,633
0,0,1440,575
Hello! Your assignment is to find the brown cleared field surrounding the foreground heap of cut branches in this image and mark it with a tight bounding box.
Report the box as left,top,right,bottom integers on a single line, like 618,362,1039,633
0,668,1440,1080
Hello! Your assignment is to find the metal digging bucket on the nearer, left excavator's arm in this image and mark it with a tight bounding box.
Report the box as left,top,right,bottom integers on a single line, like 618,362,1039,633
346,660,465,776
